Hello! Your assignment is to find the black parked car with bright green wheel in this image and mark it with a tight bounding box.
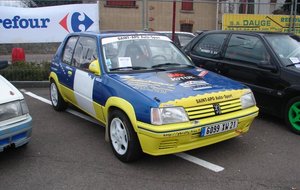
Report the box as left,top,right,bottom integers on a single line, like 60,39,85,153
184,31,300,134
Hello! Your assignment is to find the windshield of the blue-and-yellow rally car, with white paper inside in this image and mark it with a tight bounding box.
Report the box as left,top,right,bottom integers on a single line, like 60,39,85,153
102,35,192,71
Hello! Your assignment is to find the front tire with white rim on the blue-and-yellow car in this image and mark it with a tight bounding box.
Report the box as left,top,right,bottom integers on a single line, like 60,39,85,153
108,110,142,162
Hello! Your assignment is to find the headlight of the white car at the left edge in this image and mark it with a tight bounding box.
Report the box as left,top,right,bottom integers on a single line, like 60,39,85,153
0,100,29,121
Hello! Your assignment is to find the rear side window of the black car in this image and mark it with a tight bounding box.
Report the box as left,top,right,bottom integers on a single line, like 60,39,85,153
192,34,227,58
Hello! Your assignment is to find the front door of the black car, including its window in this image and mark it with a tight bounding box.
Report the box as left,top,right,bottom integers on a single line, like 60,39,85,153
219,33,284,112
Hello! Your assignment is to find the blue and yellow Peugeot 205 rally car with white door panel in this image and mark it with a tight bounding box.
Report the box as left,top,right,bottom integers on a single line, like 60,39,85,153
49,32,258,162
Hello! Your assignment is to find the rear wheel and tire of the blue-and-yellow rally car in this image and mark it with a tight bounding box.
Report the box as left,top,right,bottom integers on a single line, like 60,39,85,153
50,80,68,111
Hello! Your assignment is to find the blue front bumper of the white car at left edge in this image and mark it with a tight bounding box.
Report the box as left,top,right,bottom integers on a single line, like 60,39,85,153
0,115,32,152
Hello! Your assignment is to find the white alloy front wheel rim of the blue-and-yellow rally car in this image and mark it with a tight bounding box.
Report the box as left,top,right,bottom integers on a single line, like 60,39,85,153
110,118,128,155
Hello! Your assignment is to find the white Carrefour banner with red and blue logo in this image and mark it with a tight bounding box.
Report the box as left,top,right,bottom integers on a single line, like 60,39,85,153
0,4,99,44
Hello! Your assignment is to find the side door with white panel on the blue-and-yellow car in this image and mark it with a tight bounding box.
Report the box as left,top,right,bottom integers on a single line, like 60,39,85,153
72,36,99,117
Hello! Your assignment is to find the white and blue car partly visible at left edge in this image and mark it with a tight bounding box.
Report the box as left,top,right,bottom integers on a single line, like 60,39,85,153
0,61,32,152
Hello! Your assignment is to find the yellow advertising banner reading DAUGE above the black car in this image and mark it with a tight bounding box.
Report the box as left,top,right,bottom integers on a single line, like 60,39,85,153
222,14,300,35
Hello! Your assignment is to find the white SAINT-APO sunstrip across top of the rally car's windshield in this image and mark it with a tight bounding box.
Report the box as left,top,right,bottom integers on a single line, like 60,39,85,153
102,34,171,45
